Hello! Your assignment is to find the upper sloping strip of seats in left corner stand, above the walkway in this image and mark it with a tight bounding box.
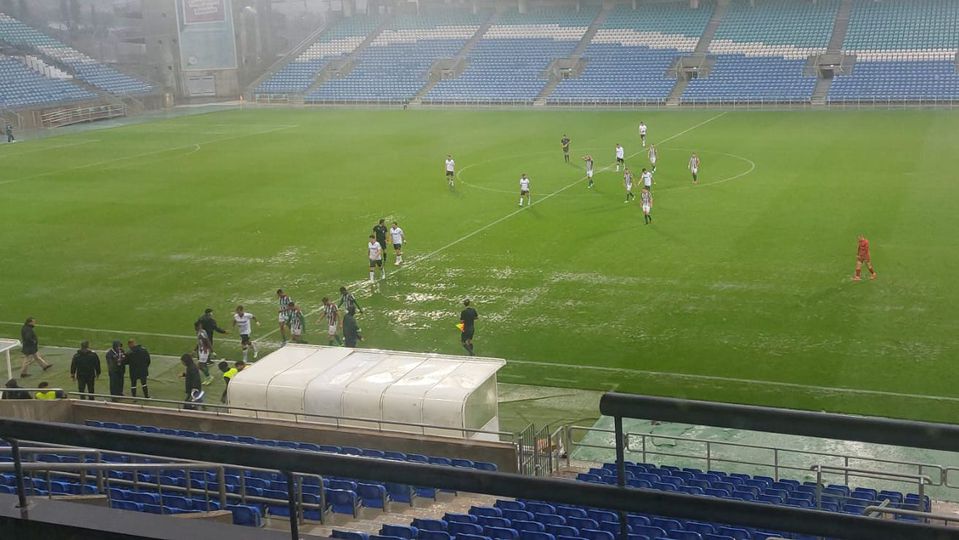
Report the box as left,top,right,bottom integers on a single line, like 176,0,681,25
0,13,153,95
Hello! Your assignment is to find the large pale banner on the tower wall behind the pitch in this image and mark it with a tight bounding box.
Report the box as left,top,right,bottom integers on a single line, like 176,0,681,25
176,0,236,71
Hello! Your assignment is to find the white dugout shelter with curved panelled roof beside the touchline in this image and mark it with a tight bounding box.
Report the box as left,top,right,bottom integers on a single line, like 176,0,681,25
229,344,506,438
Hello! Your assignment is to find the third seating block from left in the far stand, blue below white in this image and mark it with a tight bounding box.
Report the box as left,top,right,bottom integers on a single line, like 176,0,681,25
423,8,599,103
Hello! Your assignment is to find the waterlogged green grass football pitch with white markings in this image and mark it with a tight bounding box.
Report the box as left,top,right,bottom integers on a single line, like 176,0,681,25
0,110,959,421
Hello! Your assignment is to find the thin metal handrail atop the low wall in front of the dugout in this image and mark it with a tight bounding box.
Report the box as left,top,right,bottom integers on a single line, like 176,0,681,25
68,392,515,439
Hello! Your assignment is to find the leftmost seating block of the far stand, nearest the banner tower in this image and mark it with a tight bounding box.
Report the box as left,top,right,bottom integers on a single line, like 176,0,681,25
255,15,383,94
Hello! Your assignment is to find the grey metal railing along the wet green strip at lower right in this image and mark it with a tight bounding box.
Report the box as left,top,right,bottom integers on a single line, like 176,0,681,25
557,424,944,496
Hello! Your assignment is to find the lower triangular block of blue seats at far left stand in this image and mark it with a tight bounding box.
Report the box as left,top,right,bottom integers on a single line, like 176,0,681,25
0,56,97,108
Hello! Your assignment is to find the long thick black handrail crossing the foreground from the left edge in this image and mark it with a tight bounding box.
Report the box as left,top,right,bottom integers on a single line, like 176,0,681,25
0,418,959,540
